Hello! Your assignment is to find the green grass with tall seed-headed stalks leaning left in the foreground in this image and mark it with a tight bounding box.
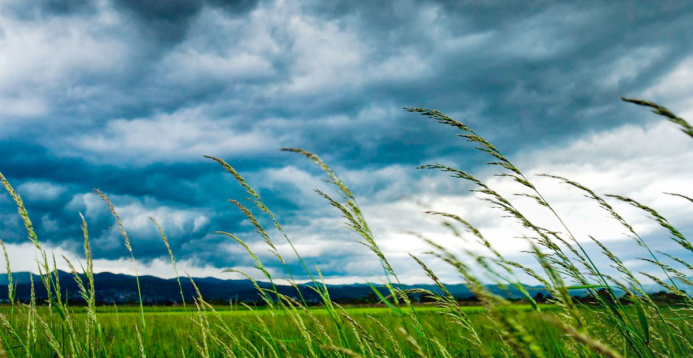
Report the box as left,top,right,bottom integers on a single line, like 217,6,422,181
0,99,693,358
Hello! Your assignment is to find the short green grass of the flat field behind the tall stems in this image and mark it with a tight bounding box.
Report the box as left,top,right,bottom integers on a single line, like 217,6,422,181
0,305,668,357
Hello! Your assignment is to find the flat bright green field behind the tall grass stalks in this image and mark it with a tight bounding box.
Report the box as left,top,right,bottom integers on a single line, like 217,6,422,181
0,305,680,357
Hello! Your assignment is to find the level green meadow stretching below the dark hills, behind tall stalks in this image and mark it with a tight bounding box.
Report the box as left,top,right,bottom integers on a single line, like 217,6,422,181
0,305,693,357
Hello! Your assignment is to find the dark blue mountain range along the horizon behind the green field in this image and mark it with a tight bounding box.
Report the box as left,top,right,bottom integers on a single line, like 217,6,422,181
0,271,676,304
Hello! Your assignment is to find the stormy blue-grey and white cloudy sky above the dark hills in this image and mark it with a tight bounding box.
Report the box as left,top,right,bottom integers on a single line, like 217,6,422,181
0,0,693,283
